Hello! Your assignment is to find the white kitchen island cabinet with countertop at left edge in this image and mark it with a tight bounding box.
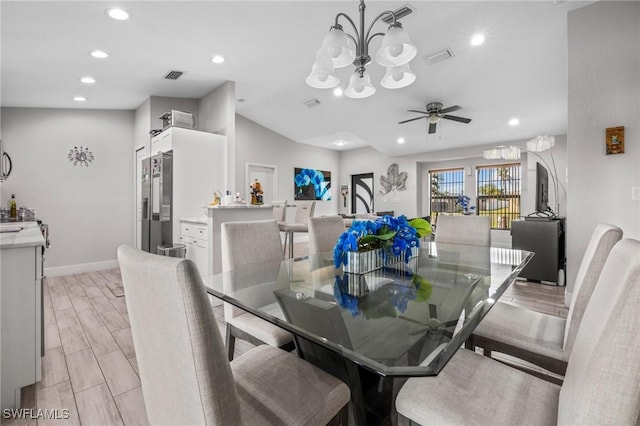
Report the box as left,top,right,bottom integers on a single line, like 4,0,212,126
0,222,45,409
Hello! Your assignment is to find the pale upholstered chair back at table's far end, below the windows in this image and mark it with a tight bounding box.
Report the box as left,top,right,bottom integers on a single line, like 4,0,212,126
434,215,491,246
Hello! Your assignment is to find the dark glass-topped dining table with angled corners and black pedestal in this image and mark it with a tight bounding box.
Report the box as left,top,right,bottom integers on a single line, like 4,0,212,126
204,242,533,424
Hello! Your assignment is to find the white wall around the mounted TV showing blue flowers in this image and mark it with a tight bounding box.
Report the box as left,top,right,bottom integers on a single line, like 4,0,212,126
234,115,340,216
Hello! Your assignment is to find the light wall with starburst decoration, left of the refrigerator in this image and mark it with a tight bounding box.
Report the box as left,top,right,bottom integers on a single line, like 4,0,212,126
0,108,134,275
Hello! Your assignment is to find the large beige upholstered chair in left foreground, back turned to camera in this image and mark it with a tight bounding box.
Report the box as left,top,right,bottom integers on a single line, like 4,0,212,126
118,246,350,425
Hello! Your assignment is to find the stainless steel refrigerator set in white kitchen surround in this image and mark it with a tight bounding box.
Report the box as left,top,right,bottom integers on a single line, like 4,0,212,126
141,152,173,253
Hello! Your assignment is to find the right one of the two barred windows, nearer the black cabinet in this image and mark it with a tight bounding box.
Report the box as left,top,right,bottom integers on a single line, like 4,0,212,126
476,164,520,229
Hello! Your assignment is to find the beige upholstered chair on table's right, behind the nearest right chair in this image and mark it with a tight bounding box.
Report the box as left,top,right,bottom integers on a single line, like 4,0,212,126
467,224,622,375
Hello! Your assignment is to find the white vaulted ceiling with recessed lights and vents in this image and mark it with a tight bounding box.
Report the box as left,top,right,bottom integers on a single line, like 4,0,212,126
0,0,586,155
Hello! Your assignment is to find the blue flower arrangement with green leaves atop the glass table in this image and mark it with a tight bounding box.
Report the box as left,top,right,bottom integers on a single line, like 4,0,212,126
333,215,431,268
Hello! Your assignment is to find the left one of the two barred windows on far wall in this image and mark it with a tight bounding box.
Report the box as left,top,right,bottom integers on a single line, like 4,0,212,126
429,169,464,218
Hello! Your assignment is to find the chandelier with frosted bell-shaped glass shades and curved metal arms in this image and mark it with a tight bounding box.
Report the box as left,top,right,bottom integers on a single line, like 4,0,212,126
306,0,417,98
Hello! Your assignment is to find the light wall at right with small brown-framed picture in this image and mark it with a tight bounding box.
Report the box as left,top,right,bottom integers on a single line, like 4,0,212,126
567,1,640,292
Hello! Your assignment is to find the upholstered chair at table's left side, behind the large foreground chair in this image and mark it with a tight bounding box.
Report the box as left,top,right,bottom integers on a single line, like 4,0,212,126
221,220,294,360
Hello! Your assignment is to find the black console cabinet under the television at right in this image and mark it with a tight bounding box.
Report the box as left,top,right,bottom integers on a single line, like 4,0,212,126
511,218,565,285
